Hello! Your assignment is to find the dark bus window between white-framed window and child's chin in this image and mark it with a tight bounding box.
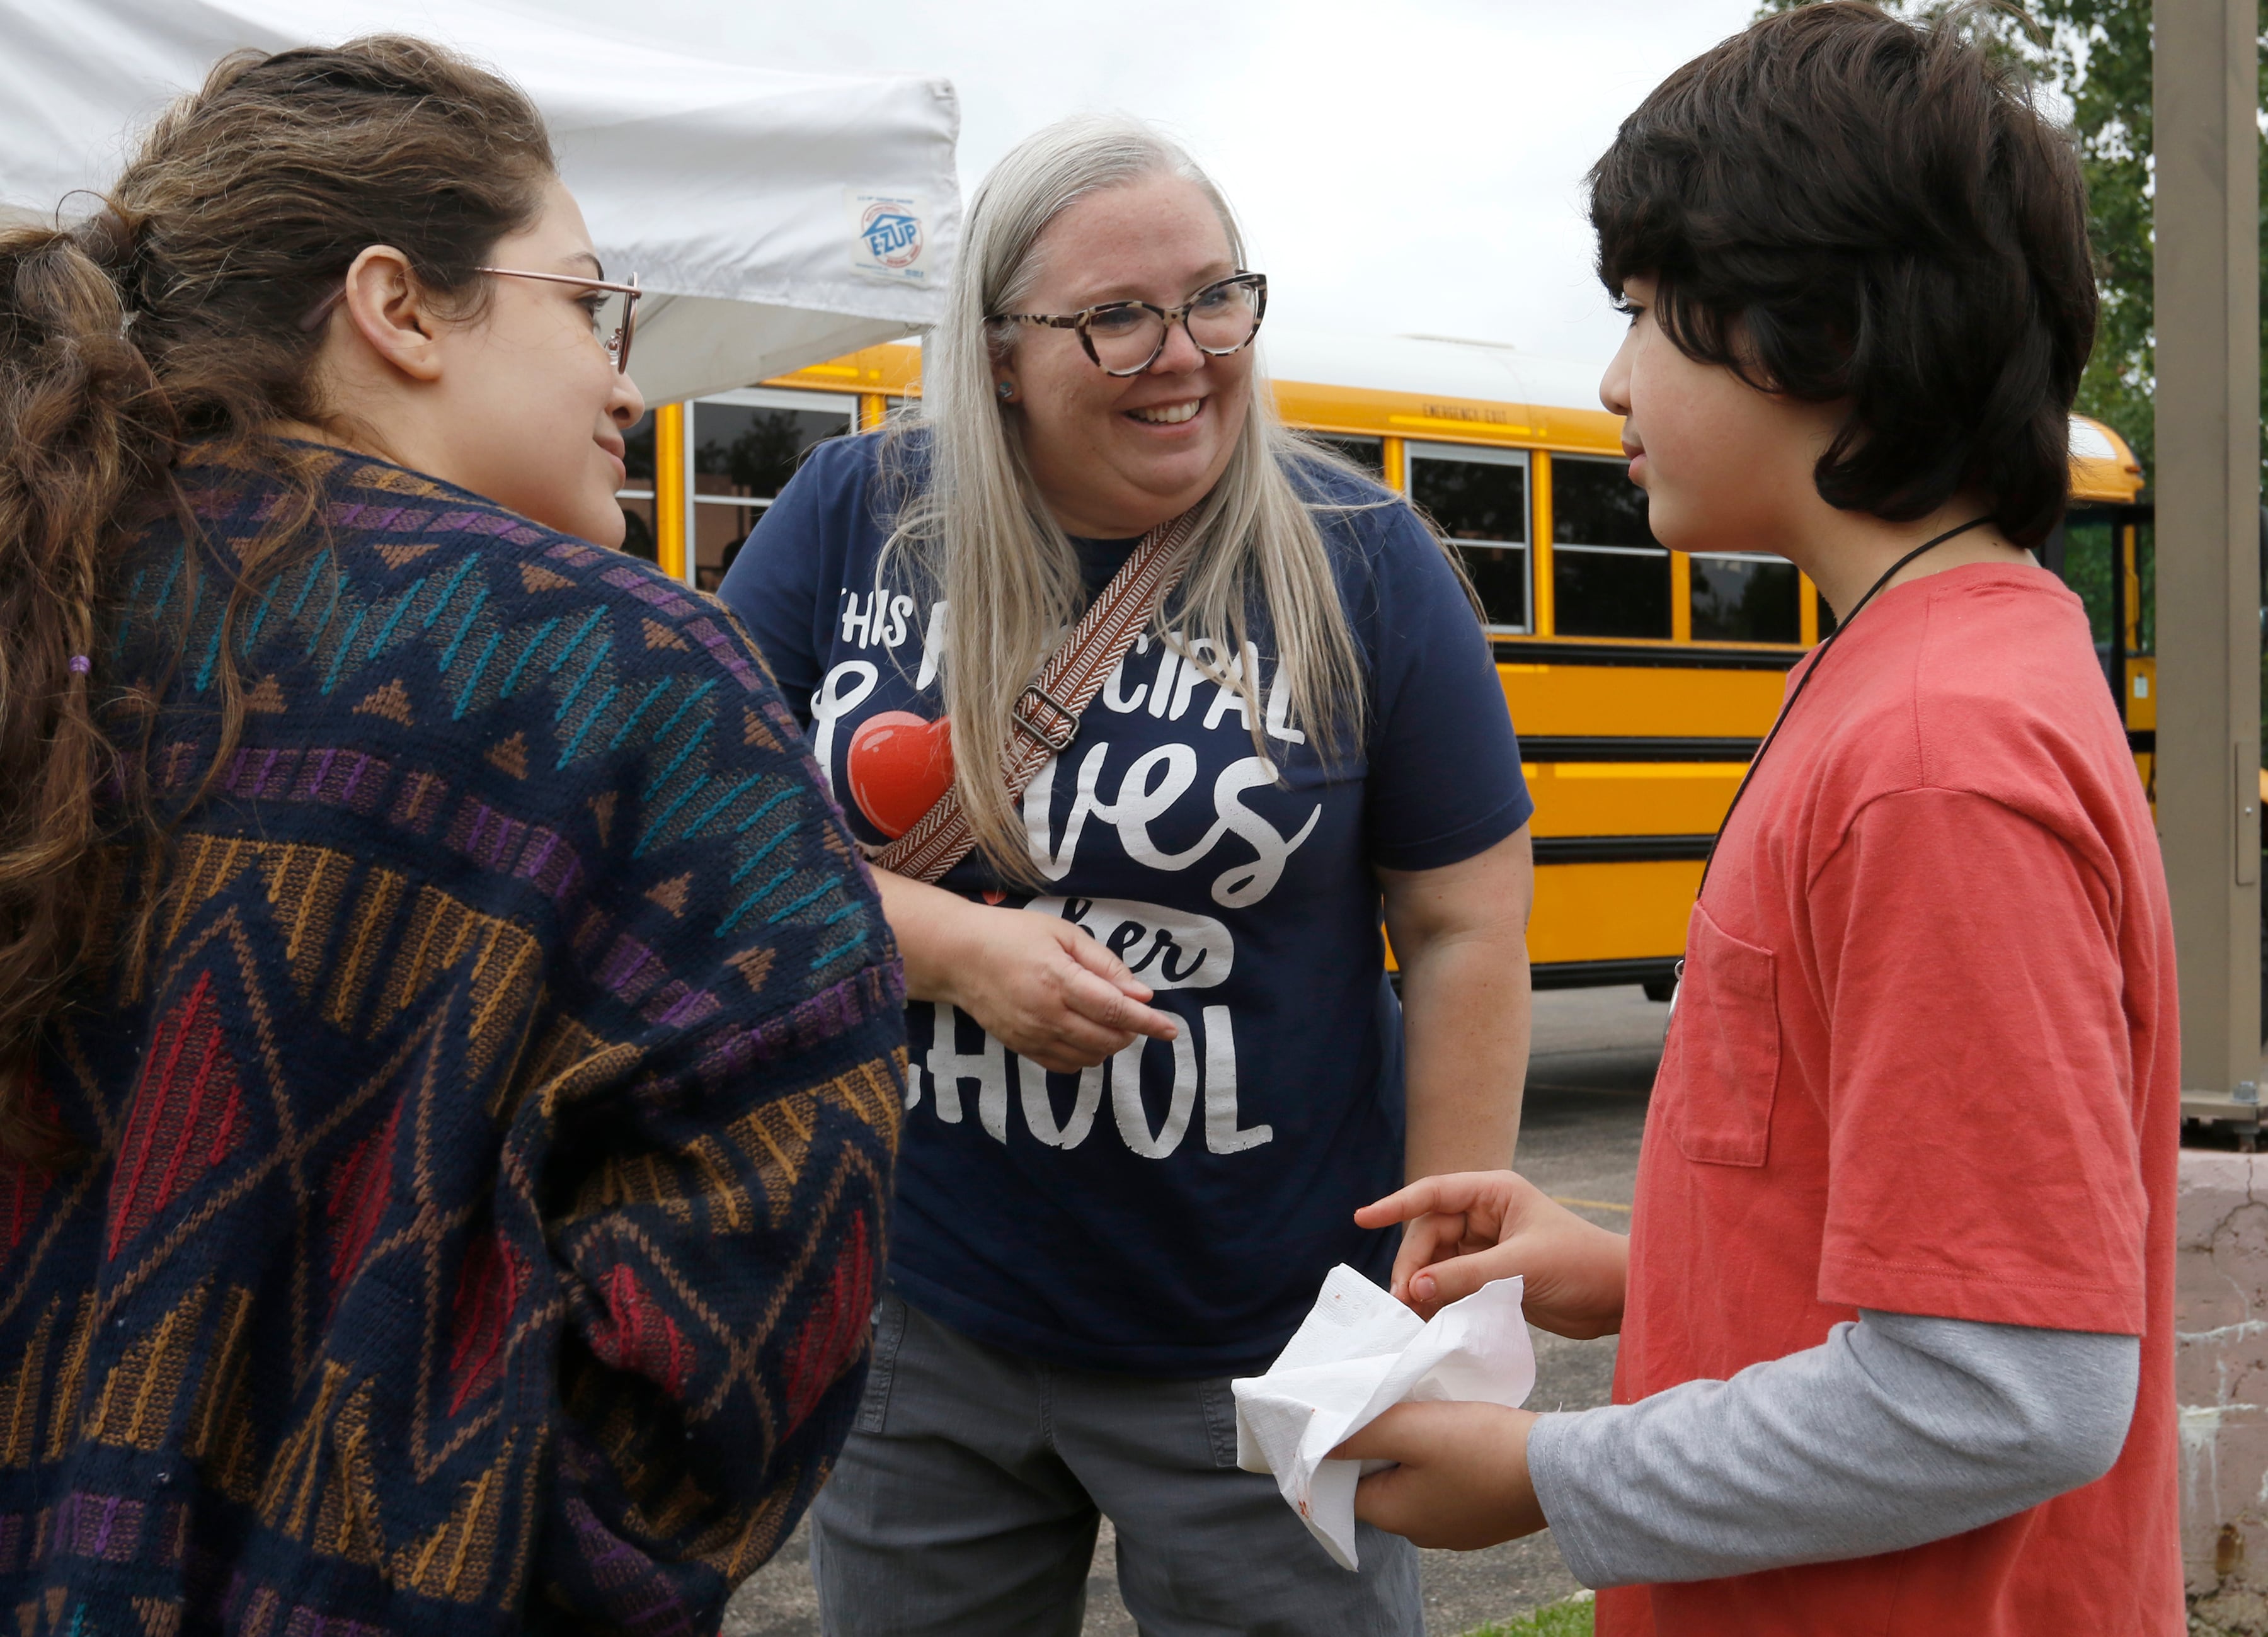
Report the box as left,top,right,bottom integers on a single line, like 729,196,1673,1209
1551,456,1670,637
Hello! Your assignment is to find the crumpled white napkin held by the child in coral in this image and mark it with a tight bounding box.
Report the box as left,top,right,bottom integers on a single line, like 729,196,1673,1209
1229,1263,1535,1569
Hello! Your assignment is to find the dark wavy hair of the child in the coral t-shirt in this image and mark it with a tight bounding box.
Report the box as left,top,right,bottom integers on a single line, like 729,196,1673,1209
1590,0,2095,547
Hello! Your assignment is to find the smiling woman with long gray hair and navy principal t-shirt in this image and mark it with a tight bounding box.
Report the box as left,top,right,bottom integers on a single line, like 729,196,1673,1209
723,118,1531,1637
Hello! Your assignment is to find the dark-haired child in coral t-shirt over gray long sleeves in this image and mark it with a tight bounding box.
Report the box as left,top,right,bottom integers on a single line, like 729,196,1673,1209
1341,4,2184,1637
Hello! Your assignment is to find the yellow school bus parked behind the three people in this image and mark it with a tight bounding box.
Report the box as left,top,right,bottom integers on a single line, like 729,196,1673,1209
624,329,2157,998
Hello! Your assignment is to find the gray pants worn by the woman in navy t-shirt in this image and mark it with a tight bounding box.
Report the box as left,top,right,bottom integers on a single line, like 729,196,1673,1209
812,1297,1424,1637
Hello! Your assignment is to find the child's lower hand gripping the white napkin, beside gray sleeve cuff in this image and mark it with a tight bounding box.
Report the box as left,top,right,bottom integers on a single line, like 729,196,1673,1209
1331,1403,1545,1551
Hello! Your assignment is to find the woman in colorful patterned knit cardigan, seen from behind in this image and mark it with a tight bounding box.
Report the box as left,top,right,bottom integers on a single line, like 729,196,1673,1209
0,38,903,1637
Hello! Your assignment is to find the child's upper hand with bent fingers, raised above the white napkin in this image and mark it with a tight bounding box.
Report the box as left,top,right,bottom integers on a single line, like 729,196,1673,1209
1354,1170,1630,1340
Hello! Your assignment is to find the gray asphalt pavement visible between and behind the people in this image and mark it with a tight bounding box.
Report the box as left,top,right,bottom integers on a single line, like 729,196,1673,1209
723,988,1670,1637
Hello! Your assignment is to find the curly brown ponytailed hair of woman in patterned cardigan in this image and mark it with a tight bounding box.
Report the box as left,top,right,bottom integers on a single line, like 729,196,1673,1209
0,37,556,1154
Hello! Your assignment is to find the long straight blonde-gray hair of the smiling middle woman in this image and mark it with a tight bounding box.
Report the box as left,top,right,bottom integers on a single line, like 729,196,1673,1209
878,116,1365,884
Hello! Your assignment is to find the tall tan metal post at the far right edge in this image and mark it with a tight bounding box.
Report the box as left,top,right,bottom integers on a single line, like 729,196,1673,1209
2152,0,2261,1113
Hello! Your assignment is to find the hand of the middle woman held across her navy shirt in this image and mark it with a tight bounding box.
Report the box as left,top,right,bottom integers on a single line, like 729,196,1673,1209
873,870,1179,1075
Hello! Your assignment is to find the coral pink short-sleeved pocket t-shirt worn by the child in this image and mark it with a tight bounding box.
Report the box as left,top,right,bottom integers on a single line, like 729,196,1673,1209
1599,564,2186,1637
